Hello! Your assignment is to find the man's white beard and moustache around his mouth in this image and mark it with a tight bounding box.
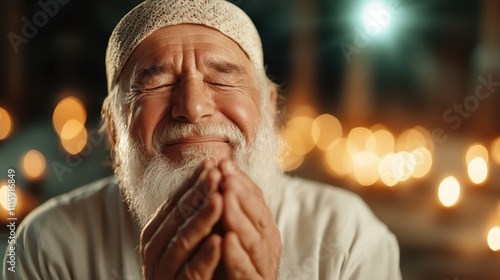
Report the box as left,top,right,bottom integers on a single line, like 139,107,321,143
115,111,284,228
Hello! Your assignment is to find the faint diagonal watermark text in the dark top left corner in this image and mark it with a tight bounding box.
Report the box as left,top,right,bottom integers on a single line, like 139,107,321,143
7,0,70,54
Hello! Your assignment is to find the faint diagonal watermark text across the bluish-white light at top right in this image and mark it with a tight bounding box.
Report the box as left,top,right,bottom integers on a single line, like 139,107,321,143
339,0,411,63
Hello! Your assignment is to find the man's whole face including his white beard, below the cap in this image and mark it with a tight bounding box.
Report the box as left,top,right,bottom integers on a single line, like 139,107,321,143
115,25,282,226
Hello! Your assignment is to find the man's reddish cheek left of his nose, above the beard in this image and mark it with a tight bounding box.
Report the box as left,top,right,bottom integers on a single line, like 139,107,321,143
130,97,168,152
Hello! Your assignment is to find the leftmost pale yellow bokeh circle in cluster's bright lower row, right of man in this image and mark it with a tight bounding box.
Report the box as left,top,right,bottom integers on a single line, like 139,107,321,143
352,151,380,186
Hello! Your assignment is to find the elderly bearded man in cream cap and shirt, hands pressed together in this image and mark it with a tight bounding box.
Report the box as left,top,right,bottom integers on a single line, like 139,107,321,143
4,0,401,279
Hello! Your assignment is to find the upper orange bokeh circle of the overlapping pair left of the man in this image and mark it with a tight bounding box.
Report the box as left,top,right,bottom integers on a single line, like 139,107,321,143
52,96,87,136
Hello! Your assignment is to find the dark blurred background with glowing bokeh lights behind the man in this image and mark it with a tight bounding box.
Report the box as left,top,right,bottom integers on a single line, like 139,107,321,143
0,0,500,280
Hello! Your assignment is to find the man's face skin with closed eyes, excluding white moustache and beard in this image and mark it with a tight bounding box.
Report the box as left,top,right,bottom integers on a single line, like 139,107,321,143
121,24,261,162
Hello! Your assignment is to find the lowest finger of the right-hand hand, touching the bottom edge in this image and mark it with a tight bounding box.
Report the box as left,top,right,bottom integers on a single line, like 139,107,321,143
222,232,262,280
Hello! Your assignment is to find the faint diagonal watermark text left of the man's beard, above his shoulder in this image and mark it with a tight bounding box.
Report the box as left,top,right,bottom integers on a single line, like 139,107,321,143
50,129,104,183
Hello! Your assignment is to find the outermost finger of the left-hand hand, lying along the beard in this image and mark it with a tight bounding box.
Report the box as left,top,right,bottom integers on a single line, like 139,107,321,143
141,160,214,240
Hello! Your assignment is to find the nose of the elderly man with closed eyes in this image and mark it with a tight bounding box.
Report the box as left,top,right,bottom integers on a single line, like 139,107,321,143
172,78,215,123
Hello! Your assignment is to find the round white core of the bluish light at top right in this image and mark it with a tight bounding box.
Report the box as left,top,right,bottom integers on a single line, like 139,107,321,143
363,2,392,36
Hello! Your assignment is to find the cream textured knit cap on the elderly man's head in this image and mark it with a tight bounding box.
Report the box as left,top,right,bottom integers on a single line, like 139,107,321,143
106,0,264,92
